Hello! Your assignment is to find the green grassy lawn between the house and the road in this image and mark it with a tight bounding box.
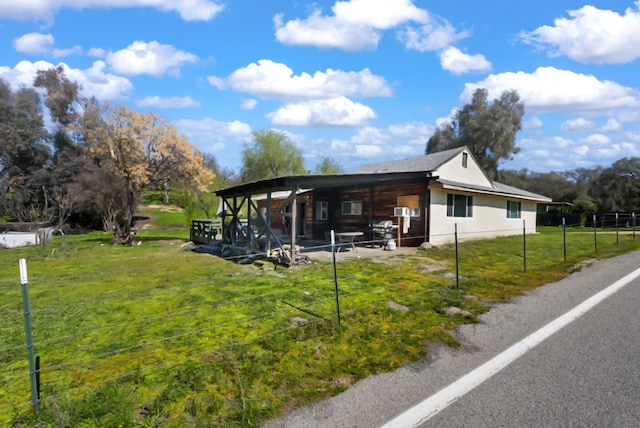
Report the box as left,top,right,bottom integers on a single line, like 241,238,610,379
0,206,640,427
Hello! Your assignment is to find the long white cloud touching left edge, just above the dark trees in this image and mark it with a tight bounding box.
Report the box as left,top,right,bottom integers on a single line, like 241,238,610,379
0,61,133,101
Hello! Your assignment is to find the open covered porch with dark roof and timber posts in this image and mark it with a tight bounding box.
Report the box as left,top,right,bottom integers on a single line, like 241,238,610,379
216,172,431,265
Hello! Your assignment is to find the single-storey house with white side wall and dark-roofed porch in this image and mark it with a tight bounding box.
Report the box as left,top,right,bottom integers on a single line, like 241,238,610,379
216,147,551,262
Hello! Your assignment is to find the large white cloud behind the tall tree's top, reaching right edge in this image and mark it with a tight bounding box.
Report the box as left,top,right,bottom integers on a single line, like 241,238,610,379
460,67,640,114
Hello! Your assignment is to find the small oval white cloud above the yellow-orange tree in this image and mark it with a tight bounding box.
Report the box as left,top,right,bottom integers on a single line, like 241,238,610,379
106,40,198,77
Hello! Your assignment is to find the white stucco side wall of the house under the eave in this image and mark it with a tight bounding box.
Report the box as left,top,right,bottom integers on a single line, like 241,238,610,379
429,189,536,245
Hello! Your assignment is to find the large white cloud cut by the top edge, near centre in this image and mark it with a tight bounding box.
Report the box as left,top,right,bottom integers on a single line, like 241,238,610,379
274,0,428,51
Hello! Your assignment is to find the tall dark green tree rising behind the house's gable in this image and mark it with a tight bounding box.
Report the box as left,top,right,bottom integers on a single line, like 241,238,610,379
426,89,524,178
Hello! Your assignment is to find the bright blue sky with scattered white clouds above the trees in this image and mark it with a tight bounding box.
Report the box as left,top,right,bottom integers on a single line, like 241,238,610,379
0,0,640,172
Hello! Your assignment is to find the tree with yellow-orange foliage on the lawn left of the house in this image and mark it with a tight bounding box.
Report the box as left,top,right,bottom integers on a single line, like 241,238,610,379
78,102,213,239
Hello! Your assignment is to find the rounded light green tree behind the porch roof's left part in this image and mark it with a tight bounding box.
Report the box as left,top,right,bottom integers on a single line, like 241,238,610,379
240,129,306,183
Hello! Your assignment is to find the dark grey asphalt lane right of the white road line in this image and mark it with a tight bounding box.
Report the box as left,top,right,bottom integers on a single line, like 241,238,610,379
421,270,640,427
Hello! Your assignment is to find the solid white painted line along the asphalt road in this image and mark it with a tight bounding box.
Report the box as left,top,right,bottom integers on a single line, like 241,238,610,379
382,269,640,428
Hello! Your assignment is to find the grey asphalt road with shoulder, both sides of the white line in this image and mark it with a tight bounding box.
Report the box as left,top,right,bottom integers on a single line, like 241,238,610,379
266,252,640,428
